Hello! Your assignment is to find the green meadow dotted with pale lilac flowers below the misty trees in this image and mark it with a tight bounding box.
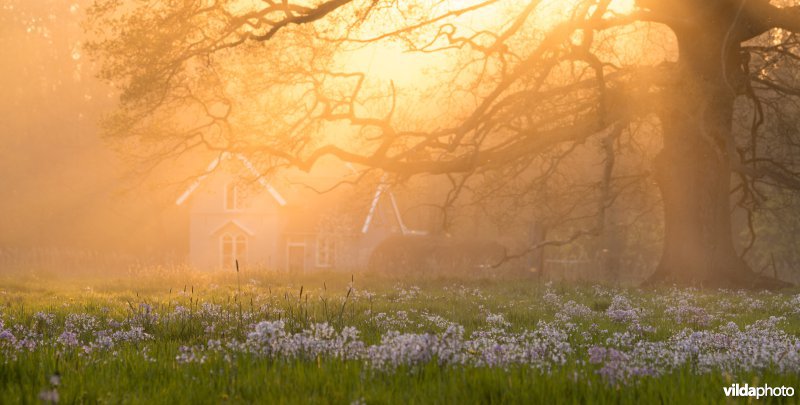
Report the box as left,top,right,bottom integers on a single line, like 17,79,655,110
0,274,800,404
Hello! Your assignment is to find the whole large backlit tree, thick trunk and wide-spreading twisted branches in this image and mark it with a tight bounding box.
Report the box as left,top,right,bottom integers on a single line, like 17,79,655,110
89,0,800,288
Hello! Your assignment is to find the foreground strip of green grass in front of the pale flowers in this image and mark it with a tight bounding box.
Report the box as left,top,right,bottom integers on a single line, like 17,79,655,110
0,352,798,404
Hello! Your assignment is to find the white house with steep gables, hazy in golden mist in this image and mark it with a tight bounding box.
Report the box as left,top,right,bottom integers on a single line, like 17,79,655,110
176,153,424,273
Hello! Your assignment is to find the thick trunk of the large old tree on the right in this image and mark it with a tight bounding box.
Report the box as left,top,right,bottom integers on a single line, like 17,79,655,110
650,19,781,288
